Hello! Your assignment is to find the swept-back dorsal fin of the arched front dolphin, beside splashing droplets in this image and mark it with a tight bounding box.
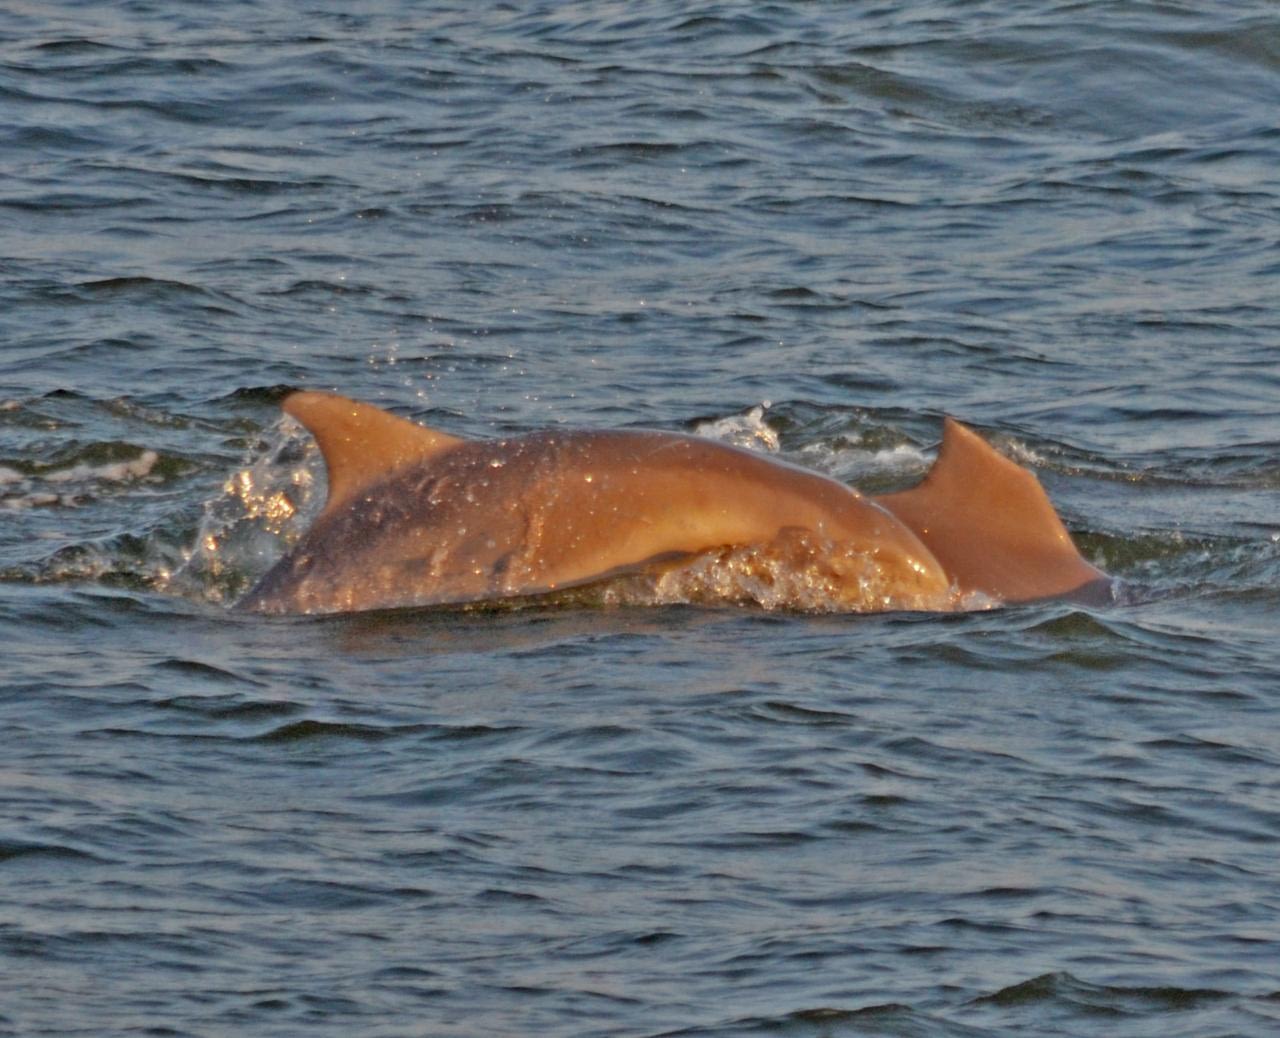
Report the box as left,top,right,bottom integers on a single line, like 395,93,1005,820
283,392,463,512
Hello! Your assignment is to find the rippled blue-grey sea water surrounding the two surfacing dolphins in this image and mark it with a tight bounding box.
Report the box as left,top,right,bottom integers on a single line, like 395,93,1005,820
0,0,1280,1037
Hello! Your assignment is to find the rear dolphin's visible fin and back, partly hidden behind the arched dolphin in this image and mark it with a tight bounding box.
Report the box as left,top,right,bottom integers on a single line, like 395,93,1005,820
876,419,1106,602
